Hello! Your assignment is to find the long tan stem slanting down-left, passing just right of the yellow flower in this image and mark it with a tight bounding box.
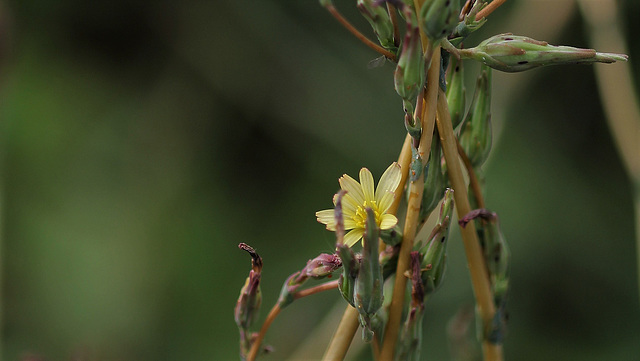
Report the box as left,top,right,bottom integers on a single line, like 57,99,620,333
380,48,440,361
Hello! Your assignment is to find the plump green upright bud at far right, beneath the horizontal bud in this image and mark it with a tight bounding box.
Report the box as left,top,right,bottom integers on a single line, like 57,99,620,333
459,66,492,168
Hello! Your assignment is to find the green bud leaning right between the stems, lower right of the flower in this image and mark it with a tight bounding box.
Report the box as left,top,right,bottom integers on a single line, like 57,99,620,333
419,189,454,295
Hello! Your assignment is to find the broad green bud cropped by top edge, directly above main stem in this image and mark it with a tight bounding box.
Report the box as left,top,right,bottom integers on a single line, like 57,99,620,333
420,0,460,46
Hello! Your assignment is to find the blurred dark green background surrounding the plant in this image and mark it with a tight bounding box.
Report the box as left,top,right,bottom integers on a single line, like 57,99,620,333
0,0,640,360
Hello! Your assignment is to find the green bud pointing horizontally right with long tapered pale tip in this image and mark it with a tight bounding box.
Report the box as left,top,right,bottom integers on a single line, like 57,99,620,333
460,34,628,73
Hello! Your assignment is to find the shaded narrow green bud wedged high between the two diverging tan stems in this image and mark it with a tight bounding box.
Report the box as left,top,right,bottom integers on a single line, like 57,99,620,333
419,130,447,223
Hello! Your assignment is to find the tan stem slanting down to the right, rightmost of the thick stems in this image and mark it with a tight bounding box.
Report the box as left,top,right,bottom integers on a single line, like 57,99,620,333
436,90,502,361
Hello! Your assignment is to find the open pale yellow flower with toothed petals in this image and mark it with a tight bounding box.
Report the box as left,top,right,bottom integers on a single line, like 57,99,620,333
316,162,402,247
